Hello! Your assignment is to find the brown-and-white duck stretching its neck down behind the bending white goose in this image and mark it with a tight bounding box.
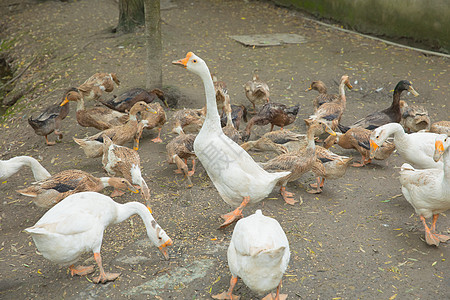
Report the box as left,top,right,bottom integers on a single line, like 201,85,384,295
102,136,150,207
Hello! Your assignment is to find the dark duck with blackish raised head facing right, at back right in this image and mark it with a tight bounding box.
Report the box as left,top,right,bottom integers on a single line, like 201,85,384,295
339,80,419,133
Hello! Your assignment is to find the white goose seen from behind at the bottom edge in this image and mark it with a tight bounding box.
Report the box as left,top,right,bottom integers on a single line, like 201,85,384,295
213,210,291,300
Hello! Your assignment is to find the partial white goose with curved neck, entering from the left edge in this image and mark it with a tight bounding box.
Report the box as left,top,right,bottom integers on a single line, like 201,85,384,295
0,156,51,181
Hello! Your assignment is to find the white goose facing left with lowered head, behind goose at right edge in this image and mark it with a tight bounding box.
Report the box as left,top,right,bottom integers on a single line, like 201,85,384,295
370,123,443,169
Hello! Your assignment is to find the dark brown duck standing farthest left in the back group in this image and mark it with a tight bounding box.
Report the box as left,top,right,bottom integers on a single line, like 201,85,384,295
28,92,69,146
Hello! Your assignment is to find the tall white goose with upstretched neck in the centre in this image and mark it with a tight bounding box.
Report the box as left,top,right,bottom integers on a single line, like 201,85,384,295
172,52,290,227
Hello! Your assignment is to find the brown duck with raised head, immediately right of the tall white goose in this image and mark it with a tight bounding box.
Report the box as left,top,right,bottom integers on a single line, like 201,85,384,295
262,120,333,205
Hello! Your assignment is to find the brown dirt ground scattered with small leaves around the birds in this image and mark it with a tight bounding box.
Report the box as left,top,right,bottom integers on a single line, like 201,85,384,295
0,0,450,299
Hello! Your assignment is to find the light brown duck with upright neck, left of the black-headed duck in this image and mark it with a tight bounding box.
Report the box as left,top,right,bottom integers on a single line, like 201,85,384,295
309,75,353,130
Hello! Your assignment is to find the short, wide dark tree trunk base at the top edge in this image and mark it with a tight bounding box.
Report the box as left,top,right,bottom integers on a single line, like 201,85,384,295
116,0,145,33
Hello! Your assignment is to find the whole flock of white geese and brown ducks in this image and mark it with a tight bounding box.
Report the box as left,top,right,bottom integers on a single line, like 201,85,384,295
0,52,450,299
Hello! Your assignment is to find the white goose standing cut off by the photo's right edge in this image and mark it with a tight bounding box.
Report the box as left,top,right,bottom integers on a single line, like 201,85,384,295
400,134,450,246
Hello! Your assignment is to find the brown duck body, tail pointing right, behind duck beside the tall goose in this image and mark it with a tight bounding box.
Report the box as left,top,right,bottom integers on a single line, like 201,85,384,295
308,146,352,194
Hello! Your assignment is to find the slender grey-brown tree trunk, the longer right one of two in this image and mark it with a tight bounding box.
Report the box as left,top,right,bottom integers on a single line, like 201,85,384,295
144,0,162,89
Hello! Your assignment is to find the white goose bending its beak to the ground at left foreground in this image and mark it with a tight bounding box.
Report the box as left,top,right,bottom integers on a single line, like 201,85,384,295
25,192,172,283
